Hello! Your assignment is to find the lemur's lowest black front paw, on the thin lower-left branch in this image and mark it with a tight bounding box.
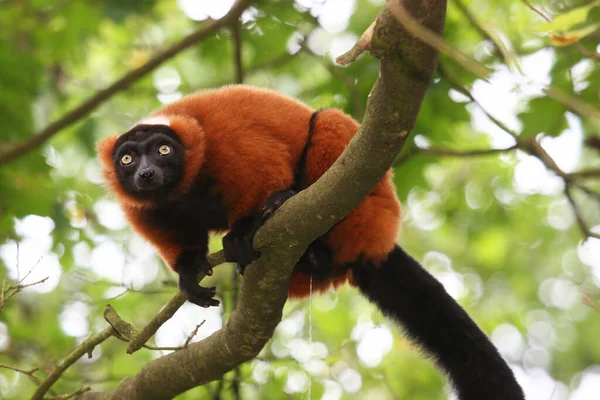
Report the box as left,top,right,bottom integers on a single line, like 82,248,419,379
175,250,219,308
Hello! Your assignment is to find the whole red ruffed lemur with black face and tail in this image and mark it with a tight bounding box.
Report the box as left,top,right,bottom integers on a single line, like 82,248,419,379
98,86,524,400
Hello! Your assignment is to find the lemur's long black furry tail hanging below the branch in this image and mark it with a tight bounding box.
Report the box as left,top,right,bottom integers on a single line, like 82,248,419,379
352,247,525,400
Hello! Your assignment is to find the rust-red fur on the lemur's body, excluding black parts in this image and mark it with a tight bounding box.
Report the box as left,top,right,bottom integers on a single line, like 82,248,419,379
98,86,400,297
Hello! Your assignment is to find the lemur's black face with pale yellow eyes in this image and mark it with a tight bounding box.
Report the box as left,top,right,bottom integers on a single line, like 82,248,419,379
113,125,184,200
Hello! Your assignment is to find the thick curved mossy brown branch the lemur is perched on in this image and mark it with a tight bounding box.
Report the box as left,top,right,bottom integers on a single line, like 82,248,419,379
79,0,446,399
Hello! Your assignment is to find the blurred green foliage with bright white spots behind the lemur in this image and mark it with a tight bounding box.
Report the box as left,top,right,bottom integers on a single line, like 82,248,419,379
0,0,600,400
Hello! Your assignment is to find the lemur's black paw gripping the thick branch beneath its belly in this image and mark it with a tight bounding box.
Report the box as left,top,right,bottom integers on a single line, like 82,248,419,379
223,189,296,275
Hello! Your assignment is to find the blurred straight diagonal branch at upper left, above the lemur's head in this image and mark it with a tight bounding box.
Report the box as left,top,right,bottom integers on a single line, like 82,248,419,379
0,0,253,166
